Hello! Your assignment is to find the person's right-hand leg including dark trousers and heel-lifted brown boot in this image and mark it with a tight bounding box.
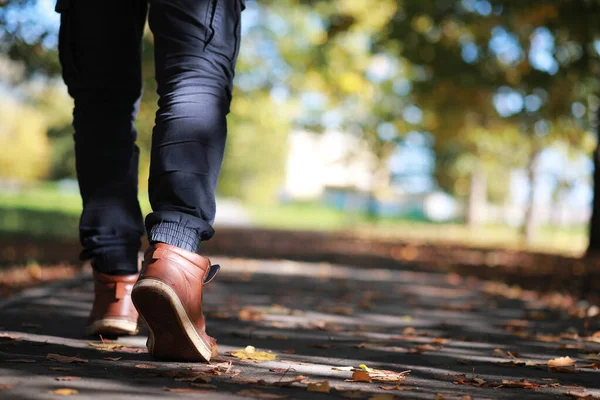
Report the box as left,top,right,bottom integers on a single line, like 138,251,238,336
132,0,243,361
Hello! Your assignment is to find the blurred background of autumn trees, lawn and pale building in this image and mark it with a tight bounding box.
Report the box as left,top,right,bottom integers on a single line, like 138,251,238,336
0,0,600,256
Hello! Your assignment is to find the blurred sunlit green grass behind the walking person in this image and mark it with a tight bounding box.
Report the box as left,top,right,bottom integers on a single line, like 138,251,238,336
0,184,587,256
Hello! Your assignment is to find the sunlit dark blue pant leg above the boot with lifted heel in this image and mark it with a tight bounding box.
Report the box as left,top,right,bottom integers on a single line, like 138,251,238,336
146,0,243,252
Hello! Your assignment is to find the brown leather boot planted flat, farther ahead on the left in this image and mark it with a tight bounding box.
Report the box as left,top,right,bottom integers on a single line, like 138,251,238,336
86,271,139,336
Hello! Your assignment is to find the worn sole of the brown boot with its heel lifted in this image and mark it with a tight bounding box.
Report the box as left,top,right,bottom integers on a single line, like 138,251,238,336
131,278,212,362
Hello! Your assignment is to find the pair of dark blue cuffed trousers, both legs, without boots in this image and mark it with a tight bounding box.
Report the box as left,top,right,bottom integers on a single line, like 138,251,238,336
56,0,244,274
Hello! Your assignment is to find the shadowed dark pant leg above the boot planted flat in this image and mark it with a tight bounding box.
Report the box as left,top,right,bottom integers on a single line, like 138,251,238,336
56,0,147,274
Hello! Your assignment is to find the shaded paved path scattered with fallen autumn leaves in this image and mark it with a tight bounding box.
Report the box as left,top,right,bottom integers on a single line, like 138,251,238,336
0,258,600,400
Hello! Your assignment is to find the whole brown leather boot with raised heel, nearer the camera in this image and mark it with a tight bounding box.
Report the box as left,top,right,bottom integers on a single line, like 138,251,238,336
132,243,220,362
